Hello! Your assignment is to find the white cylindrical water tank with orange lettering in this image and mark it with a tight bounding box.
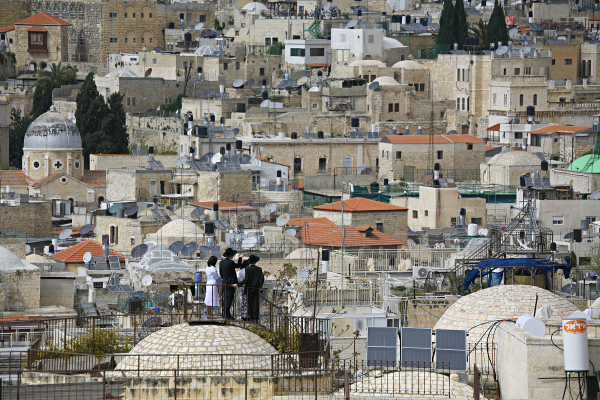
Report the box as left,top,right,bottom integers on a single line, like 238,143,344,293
562,318,590,372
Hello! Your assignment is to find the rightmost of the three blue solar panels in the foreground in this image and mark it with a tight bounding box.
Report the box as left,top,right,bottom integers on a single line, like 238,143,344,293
435,329,467,371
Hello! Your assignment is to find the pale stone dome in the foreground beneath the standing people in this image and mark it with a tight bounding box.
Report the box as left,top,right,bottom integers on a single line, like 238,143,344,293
116,324,278,376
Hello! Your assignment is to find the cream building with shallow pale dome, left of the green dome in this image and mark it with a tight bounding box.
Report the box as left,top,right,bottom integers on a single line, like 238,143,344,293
481,150,542,186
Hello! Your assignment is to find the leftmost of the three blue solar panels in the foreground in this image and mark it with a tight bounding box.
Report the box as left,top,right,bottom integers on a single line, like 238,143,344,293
367,326,398,367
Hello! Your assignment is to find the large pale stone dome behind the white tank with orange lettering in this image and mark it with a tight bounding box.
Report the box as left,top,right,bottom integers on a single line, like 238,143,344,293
435,285,577,343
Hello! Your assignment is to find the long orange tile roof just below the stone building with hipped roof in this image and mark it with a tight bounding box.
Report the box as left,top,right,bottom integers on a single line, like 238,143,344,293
298,224,403,248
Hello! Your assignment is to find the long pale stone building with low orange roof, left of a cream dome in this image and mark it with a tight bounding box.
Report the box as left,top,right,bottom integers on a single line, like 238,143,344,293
379,135,485,181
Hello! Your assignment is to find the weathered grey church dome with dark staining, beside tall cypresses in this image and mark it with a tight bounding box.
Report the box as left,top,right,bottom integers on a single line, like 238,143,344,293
23,107,82,150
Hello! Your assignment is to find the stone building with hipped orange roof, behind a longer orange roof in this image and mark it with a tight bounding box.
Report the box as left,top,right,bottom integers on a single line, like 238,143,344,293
313,197,408,243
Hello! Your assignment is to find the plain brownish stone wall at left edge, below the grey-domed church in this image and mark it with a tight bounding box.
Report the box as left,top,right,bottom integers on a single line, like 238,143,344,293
0,201,52,238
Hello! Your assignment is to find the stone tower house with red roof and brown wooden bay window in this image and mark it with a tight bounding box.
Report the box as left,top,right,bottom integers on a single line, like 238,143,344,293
13,12,71,71
